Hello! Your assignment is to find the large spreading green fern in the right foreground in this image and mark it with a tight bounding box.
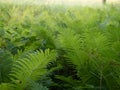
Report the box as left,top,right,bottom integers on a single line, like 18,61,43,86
58,30,119,89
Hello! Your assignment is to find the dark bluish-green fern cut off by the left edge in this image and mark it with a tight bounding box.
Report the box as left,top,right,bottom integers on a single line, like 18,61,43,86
0,49,13,83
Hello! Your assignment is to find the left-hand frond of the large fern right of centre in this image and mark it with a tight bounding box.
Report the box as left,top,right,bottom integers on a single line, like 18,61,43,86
58,30,85,66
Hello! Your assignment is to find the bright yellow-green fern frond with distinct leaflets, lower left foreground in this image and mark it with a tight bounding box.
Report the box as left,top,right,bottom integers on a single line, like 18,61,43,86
11,49,56,89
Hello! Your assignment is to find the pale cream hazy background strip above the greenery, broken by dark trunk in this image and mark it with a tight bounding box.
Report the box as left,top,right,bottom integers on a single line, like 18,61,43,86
0,0,120,5
